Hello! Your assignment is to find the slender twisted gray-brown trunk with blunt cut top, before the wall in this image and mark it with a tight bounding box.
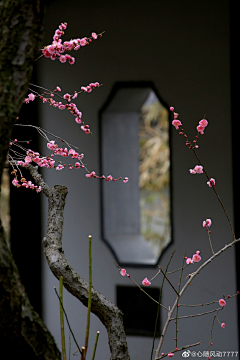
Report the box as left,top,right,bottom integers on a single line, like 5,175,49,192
27,165,130,360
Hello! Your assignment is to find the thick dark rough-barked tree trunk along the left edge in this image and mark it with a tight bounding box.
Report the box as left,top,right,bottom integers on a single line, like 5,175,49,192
0,0,61,360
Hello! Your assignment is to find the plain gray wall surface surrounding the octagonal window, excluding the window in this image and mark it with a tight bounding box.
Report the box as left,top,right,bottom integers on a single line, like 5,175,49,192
38,0,238,360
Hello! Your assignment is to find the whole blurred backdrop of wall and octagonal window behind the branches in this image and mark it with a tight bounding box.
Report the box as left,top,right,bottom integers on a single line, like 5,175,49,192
2,0,240,360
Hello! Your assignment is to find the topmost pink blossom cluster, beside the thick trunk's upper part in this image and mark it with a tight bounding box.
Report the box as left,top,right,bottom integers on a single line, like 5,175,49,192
42,23,102,65
